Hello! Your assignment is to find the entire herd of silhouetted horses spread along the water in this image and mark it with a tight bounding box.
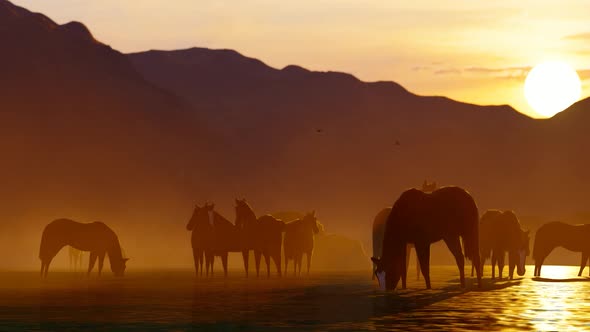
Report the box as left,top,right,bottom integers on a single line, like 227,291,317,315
39,182,590,289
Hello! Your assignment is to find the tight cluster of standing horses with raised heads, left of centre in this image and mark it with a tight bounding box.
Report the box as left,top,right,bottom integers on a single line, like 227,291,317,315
186,199,319,277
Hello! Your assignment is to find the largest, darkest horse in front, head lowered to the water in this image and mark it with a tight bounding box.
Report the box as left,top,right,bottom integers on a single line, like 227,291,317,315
371,187,481,289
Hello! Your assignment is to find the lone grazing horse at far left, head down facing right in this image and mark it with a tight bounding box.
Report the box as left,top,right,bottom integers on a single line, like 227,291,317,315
39,219,129,277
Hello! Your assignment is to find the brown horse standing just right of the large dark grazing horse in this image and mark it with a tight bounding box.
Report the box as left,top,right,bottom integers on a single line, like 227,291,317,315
471,210,530,280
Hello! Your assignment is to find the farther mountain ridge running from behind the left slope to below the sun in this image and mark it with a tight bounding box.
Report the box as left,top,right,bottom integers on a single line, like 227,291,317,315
128,48,590,249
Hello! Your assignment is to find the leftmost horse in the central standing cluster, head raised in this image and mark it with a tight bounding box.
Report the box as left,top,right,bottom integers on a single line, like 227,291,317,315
186,203,213,277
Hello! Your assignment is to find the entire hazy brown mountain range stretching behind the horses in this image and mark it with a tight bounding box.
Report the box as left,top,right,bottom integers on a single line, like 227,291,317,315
0,0,590,266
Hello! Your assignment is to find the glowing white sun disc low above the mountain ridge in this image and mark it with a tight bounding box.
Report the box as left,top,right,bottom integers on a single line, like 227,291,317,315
524,61,582,118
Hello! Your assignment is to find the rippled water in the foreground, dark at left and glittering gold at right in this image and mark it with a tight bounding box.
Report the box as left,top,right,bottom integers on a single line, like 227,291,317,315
0,266,590,331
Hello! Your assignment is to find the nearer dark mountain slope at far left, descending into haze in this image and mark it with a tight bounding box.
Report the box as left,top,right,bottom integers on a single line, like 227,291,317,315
0,0,217,231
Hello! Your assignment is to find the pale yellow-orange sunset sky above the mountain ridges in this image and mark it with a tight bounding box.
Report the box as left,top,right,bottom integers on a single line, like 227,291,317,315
14,0,590,117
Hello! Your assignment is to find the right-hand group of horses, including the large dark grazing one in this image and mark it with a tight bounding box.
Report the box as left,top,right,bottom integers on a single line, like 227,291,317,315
371,186,590,289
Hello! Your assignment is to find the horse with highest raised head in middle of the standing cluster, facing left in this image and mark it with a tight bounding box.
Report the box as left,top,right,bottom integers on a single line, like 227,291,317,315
236,199,285,277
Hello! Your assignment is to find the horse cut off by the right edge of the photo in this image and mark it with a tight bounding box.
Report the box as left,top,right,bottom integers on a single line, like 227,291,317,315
533,221,590,277
